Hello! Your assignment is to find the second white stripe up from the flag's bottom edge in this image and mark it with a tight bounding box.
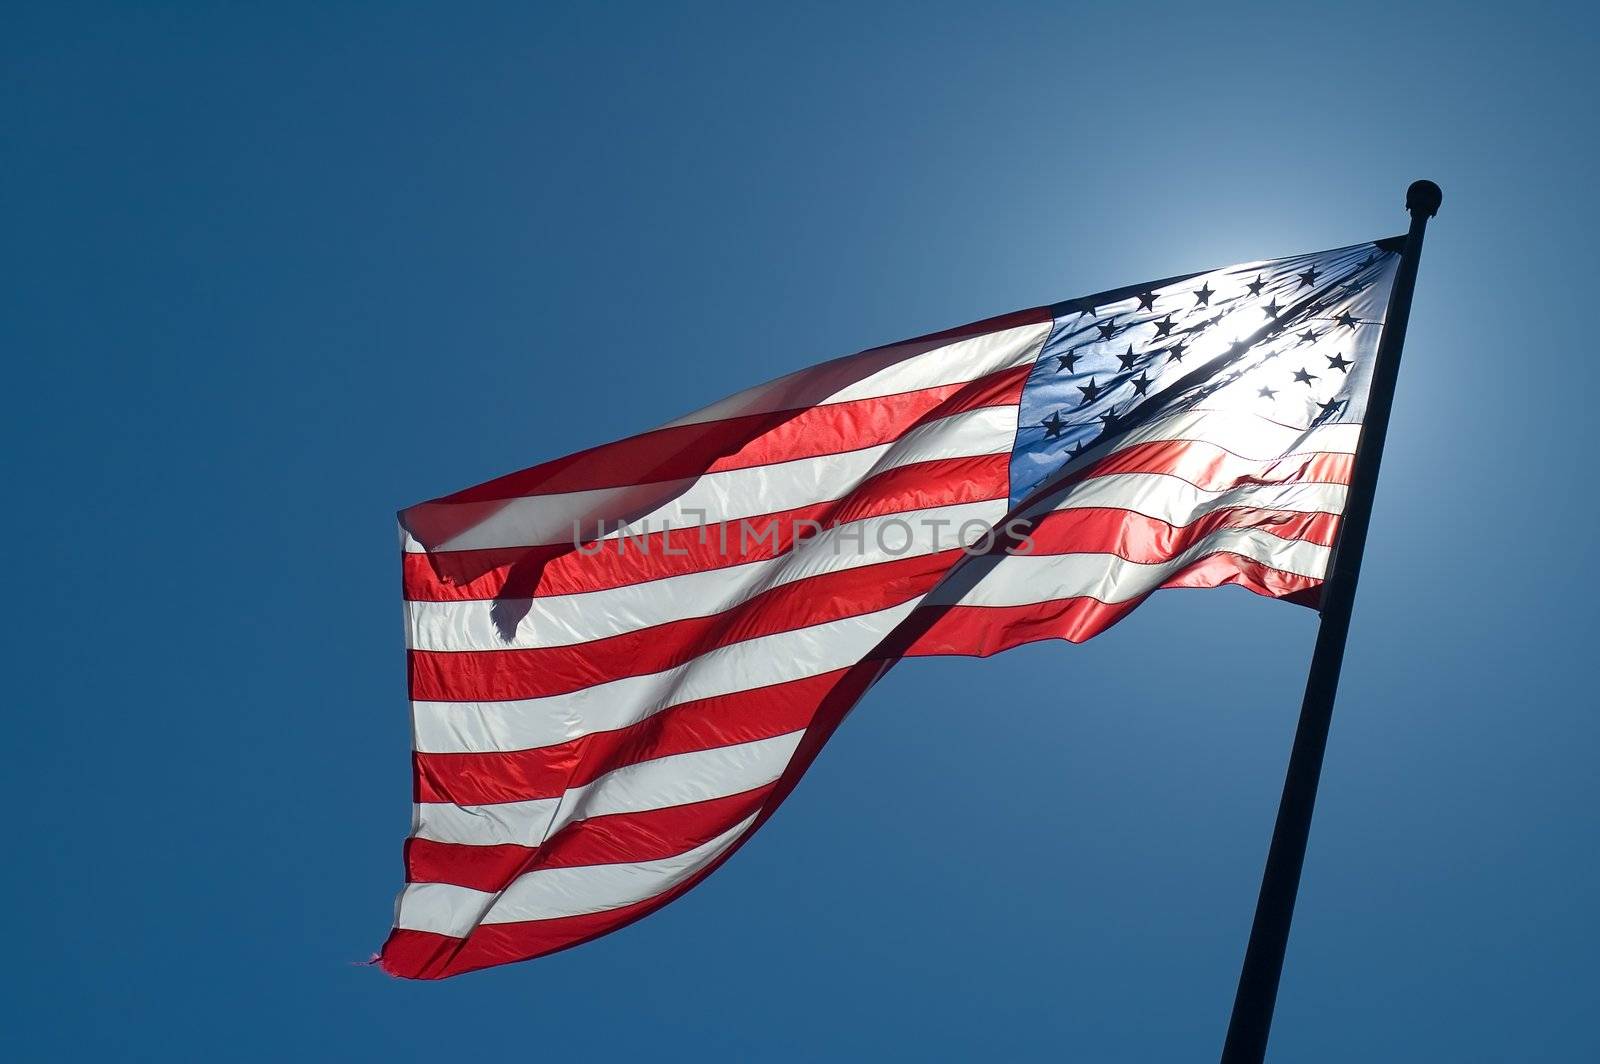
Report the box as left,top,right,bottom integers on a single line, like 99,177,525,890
411,730,805,846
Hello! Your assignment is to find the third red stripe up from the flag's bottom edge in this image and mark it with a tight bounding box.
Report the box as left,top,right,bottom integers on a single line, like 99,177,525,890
413,669,845,805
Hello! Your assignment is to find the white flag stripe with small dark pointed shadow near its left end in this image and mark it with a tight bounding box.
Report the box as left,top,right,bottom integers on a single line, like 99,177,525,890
406,499,1006,651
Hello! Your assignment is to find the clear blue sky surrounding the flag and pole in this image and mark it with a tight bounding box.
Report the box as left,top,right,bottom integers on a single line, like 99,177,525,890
0,2,1600,1061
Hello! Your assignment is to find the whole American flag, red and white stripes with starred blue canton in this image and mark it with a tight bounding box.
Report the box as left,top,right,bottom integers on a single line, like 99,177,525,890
378,240,1400,979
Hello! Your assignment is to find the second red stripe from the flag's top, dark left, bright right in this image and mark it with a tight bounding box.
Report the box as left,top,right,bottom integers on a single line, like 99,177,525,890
400,365,1032,546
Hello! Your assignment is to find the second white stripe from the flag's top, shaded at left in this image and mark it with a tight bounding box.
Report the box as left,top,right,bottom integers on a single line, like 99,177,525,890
406,406,1016,552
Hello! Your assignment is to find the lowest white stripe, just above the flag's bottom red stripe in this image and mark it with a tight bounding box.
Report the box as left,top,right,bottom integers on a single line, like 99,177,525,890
395,814,755,938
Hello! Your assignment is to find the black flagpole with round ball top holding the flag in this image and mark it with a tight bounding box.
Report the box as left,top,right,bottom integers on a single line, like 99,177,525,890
1222,181,1443,1064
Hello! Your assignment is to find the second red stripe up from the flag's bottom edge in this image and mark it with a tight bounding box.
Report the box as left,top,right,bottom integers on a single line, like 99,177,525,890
405,784,771,891
